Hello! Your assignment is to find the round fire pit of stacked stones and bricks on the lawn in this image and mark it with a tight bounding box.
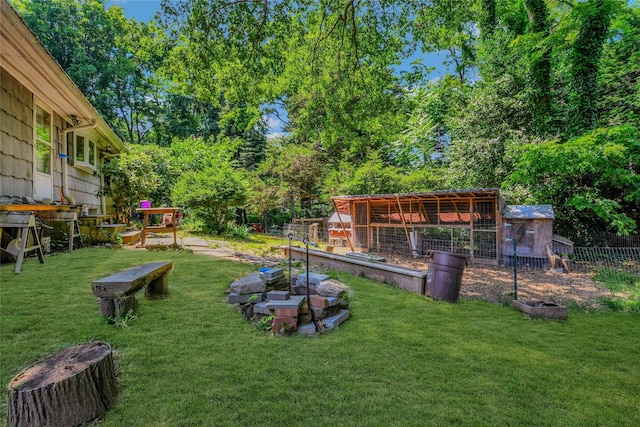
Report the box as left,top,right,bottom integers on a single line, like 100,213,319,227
227,268,349,335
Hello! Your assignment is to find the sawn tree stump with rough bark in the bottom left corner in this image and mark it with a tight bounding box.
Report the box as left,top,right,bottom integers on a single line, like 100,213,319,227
7,342,117,427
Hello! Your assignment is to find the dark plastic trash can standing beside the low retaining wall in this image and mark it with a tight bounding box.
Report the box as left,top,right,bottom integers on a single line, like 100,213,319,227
425,251,467,302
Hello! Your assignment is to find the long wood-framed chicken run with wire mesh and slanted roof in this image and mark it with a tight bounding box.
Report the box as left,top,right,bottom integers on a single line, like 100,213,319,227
331,188,503,265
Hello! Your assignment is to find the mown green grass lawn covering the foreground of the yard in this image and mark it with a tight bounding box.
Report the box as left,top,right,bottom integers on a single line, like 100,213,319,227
0,248,640,426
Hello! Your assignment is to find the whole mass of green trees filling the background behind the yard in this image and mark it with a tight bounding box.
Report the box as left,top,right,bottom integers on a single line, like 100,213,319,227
12,0,640,242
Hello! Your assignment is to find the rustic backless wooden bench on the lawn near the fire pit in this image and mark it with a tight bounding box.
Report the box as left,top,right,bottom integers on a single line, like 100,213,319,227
91,262,173,319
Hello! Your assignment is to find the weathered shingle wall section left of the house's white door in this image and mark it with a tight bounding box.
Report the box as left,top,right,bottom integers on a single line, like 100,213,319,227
0,68,33,197
